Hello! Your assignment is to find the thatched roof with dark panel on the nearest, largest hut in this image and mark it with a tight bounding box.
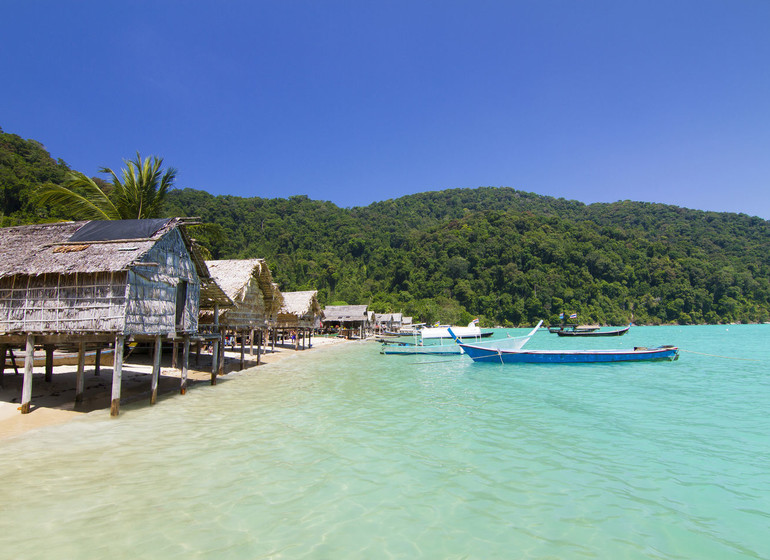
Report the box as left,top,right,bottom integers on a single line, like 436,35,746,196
0,218,231,305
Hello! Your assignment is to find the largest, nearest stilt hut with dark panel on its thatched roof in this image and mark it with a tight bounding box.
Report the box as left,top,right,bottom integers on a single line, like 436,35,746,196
0,218,230,415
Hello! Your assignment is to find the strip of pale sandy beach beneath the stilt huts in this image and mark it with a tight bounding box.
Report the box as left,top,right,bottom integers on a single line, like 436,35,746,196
0,337,345,439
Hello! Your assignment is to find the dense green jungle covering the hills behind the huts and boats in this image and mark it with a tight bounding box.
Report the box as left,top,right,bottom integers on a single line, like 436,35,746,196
0,124,770,326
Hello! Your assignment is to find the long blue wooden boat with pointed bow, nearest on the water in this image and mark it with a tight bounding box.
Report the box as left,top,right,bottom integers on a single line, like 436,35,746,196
458,343,679,364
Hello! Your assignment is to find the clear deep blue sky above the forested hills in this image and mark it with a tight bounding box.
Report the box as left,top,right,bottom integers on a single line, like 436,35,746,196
0,0,770,219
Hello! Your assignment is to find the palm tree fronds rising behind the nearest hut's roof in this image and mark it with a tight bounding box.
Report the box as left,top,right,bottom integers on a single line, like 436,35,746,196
36,152,176,220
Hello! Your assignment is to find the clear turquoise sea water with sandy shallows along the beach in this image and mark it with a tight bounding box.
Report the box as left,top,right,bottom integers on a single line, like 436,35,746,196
0,325,770,559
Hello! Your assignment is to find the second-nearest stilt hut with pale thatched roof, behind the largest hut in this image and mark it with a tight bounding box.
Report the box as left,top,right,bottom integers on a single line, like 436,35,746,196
200,259,283,369
